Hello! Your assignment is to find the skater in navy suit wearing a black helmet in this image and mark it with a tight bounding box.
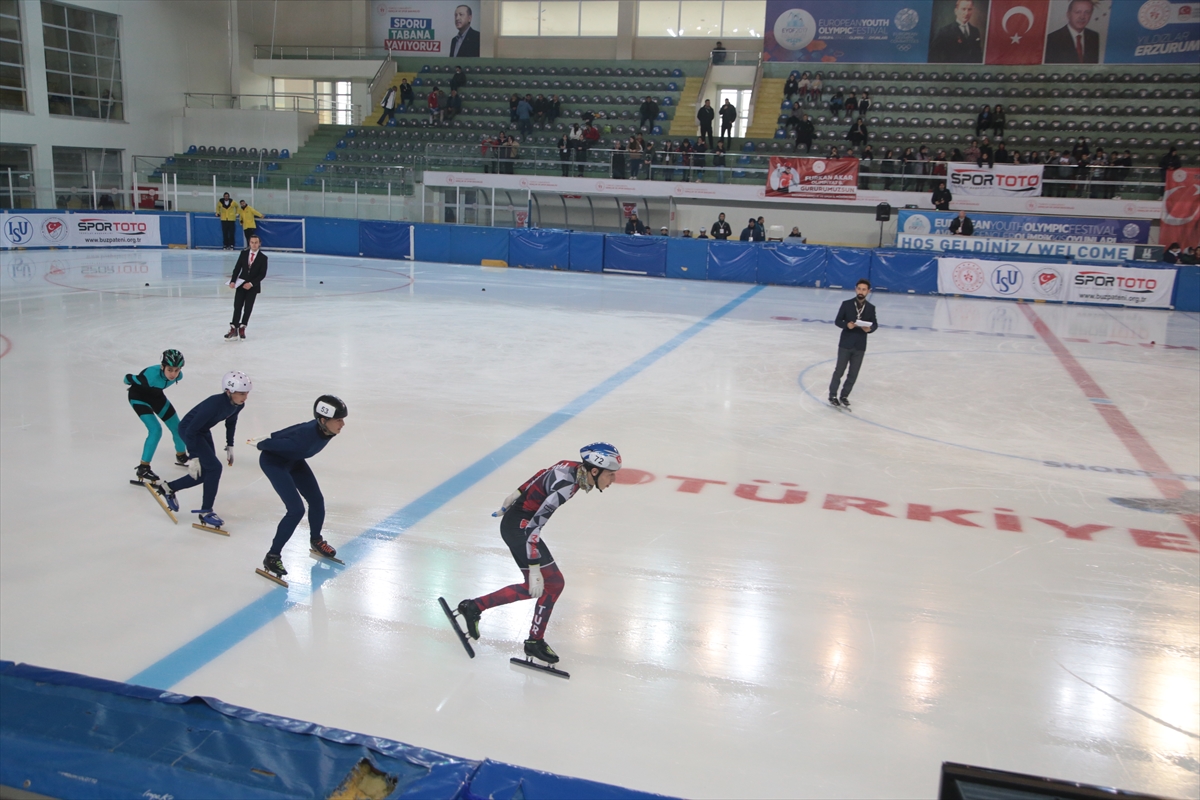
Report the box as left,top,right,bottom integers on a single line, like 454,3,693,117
254,395,347,577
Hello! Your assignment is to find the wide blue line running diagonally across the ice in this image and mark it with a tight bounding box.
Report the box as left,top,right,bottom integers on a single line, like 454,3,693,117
126,285,766,691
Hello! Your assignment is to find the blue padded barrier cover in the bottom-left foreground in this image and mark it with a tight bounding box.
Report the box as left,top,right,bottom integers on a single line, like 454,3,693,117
0,661,664,800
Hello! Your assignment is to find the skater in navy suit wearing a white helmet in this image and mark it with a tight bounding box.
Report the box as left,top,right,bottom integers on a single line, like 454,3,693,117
156,372,253,528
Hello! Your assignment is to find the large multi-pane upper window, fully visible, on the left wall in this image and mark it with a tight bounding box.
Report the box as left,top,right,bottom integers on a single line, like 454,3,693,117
42,2,125,120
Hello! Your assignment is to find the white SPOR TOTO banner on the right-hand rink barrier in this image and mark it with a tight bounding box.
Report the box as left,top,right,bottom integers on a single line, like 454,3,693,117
937,258,1175,308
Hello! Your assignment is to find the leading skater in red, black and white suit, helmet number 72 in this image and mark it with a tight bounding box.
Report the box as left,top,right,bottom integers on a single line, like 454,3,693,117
458,441,620,663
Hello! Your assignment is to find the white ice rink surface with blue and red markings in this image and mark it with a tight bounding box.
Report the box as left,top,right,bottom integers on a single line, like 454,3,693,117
0,251,1200,798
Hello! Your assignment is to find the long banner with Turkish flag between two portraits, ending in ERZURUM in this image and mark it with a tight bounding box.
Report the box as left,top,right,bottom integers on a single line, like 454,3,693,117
763,0,1200,68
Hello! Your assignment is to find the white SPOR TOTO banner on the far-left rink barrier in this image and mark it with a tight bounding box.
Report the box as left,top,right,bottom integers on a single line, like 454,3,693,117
0,212,162,247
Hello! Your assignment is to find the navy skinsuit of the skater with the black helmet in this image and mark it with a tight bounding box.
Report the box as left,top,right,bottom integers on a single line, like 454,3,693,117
258,420,332,555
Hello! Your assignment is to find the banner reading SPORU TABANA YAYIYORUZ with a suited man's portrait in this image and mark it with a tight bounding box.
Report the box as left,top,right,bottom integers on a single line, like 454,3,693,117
371,0,480,59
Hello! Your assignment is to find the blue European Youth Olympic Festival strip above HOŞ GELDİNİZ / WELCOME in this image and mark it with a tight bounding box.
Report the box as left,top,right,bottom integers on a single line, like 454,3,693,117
896,208,1152,245
